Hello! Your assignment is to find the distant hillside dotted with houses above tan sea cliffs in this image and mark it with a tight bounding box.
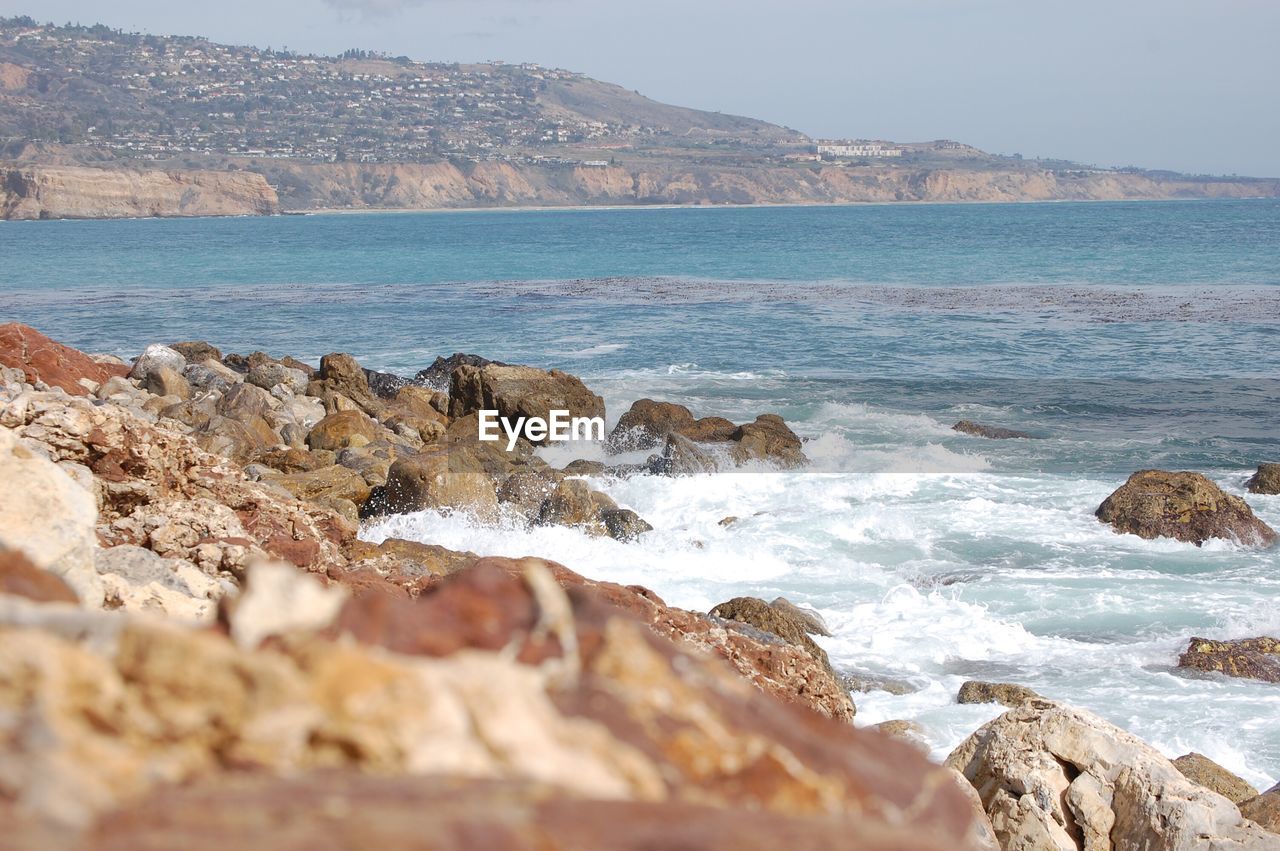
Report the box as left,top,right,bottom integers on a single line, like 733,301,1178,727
0,18,1280,218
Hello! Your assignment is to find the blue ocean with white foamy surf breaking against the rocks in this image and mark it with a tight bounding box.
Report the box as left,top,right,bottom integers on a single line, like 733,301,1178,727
0,200,1280,788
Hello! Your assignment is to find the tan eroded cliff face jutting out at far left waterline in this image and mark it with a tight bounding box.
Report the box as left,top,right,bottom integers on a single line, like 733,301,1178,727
0,165,280,219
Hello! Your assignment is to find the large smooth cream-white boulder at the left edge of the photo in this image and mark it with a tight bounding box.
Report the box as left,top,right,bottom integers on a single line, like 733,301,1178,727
0,427,102,608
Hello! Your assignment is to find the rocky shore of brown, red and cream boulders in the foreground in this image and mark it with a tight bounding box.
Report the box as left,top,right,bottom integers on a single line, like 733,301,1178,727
0,324,1280,851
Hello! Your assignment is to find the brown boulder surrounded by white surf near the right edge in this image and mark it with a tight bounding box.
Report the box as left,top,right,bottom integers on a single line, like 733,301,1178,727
1097,470,1276,546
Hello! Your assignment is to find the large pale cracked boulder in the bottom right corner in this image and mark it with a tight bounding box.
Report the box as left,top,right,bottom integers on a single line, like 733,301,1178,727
946,700,1276,851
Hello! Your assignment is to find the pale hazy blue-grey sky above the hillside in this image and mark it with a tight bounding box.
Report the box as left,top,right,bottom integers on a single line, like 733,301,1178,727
0,0,1280,177
